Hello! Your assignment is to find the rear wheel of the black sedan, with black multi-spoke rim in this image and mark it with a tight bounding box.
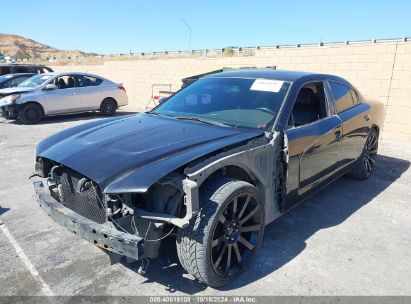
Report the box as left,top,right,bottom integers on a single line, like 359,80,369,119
348,129,378,181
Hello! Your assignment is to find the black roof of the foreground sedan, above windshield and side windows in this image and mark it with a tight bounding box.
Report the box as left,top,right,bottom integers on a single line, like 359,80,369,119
204,69,348,83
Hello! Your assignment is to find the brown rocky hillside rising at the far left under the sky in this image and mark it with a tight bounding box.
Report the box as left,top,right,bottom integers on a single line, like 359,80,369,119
0,33,88,59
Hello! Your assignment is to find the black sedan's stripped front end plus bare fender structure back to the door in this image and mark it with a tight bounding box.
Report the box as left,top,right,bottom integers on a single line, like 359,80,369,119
34,125,281,262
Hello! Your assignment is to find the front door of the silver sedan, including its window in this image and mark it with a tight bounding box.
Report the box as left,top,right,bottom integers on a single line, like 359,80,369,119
43,75,81,114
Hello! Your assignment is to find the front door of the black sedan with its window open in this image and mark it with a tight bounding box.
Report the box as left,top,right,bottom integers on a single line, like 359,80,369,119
282,81,342,211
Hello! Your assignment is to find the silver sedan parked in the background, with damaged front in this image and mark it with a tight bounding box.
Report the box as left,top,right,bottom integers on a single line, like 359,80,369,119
0,72,128,124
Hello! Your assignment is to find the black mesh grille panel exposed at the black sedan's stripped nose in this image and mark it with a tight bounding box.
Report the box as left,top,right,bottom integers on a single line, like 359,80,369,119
60,168,106,224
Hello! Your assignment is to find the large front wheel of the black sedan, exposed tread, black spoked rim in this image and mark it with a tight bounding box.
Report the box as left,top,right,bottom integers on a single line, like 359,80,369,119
176,178,265,287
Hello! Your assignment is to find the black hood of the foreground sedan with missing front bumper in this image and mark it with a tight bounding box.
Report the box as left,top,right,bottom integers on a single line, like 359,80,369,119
36,113,263,193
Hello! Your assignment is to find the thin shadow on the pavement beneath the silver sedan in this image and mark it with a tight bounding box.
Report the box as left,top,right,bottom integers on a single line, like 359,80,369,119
9,111,138,125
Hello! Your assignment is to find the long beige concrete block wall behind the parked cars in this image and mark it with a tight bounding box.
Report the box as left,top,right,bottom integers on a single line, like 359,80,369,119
53,41,411,142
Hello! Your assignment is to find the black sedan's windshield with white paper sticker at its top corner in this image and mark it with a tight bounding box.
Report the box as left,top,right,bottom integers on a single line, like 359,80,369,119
151,78,290,129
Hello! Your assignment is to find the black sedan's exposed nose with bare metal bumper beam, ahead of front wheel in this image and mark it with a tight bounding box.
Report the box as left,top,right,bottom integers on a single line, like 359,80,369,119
34,158,198,261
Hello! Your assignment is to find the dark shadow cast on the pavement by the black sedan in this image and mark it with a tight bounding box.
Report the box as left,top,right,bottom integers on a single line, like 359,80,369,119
124,155,410,295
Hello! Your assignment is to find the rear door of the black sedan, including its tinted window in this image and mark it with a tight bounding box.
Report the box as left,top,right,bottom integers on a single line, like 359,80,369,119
328,81,370,166
